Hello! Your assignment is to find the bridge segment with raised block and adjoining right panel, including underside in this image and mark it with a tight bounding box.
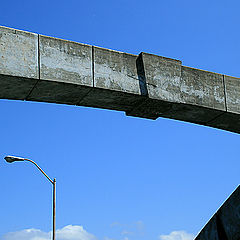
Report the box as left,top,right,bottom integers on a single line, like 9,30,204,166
127,53,226,125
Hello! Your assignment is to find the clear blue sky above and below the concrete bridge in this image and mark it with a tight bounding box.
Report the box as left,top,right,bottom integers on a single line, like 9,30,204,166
0,0,240,240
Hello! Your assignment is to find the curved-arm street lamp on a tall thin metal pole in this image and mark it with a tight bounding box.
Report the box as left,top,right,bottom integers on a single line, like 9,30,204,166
4,156,56,240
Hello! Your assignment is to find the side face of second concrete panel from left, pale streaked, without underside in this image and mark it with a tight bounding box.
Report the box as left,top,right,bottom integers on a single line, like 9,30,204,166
40,35,93,87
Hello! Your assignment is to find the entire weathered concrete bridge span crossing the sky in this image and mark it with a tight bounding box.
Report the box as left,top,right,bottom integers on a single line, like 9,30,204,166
0,27,240,133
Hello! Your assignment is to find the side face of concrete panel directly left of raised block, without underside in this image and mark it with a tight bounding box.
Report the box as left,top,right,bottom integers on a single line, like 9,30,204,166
93,47,141,95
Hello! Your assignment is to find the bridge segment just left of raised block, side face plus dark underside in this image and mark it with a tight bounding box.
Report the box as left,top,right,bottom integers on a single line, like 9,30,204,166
79,47,143,111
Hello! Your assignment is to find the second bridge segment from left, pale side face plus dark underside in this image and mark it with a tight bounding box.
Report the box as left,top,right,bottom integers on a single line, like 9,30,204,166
26,35,93,105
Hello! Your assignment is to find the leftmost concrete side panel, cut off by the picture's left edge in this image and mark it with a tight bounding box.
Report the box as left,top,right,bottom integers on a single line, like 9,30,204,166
0,27,38,79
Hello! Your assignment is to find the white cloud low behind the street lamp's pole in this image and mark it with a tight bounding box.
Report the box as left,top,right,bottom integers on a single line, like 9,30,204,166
0,225,96,240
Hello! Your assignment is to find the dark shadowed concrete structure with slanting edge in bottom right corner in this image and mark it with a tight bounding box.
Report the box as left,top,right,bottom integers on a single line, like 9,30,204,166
195,186,240,240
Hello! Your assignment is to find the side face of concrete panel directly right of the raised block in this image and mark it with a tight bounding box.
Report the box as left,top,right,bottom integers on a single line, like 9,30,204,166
181,66,226,110
